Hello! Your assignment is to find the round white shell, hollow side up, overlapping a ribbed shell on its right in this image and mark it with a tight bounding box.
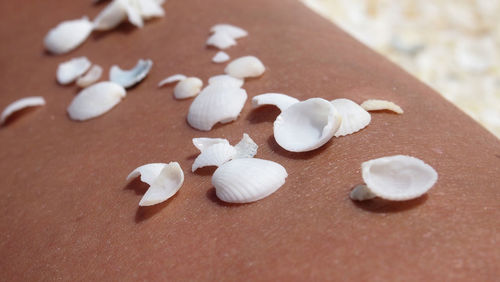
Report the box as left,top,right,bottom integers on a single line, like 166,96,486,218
274,98,342,152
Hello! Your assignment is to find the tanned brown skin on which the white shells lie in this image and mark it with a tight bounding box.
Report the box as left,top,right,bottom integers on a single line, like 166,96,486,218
0,0,500,281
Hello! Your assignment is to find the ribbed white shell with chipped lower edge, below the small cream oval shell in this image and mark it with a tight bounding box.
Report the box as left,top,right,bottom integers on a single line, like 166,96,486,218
187,85,247,131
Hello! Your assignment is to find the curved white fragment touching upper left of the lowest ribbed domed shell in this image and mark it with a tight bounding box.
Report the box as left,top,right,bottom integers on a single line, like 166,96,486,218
191,143,236,172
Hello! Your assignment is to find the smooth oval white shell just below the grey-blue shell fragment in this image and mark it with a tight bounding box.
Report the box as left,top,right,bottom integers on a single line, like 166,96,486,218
68,81,126,121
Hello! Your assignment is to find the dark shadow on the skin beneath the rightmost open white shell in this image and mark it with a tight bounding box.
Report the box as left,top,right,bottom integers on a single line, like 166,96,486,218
353,194,429,213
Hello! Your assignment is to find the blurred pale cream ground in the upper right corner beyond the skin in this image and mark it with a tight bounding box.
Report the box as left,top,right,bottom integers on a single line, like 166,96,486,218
302,0,500,137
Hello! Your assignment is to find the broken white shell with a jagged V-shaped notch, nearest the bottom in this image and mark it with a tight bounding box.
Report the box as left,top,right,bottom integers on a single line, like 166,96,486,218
127,162,184,206
